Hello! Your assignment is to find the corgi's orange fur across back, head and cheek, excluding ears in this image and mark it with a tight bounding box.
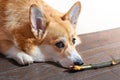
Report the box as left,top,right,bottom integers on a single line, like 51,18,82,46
0,0,82,66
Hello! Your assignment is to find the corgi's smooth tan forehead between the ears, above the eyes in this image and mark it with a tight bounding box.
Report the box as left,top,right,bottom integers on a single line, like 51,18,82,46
48,21,75,37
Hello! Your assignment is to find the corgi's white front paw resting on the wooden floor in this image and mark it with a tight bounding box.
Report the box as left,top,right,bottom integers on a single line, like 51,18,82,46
14,52,33,65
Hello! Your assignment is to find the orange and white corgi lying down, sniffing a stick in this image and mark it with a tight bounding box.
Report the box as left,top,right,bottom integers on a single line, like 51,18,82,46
0,0,83,67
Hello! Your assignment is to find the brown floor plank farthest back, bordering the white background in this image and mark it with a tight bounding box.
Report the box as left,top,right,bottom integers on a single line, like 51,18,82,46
77,28,120,51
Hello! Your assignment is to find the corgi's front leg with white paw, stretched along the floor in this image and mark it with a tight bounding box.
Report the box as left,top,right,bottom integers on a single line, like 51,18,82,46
0,40,33,65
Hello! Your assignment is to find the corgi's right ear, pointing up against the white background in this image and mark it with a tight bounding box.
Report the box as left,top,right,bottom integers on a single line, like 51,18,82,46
62,1,81,27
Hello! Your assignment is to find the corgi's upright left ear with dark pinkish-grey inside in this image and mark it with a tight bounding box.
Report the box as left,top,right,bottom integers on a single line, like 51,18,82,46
30,5,46,38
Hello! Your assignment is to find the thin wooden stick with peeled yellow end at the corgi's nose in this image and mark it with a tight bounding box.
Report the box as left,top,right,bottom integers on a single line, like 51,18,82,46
69,59,120,71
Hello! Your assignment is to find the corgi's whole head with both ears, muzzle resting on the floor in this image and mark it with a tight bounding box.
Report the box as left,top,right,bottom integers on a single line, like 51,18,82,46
30,2,83,67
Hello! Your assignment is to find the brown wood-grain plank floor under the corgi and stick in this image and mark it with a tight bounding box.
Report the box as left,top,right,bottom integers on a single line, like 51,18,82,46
0,28,120,80
